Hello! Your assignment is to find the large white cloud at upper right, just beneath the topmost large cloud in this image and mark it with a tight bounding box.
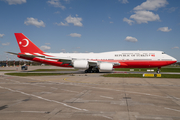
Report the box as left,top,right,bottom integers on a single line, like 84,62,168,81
130,11,160,24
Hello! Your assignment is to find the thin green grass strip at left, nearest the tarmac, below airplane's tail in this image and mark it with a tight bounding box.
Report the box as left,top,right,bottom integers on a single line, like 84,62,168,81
5,73,67,76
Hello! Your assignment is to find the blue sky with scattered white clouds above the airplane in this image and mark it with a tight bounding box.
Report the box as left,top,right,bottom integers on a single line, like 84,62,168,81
0,0,180,62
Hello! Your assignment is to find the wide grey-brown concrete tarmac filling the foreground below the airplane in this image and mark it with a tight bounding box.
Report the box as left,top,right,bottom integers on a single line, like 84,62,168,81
0,68,180,120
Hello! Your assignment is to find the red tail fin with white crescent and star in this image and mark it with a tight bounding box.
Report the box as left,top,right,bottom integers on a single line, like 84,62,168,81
14,33,44,53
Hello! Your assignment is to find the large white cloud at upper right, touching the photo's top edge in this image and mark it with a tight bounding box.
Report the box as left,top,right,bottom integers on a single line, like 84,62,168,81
133,0,168,11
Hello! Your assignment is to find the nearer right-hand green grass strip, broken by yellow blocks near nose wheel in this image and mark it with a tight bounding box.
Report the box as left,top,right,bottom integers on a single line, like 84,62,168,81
103,74,180,78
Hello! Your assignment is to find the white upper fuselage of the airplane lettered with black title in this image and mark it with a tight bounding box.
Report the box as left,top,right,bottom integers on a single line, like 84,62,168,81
46,51,176,61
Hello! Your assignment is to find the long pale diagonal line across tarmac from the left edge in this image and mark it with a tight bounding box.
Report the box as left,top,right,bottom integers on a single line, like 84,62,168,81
0,86,88,111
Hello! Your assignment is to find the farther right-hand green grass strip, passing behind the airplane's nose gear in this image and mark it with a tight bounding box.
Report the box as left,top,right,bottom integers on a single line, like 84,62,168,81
115,67,180,72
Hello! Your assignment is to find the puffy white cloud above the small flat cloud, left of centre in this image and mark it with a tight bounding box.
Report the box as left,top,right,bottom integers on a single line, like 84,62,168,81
65,15,83,27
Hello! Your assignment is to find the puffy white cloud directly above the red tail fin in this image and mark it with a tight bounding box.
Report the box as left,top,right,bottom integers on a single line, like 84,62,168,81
24,17,45,28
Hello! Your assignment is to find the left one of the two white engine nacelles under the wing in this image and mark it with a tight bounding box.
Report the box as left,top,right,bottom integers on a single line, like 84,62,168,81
73,60,89,69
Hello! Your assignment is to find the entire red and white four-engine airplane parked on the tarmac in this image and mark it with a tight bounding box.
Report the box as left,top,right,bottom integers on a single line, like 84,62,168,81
7,33,177,73
